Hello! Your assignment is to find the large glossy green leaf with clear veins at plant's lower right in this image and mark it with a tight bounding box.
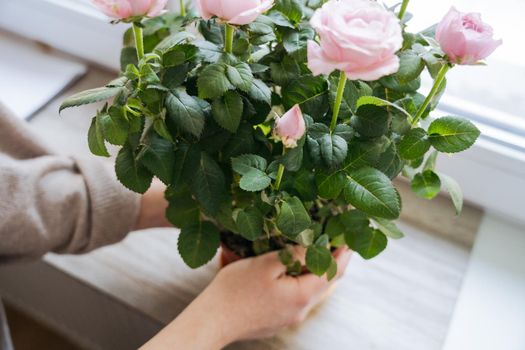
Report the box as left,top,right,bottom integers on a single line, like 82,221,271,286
344,167,401,219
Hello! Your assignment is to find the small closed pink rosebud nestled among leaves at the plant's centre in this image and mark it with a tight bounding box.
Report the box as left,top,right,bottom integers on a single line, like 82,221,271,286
273,105,306,148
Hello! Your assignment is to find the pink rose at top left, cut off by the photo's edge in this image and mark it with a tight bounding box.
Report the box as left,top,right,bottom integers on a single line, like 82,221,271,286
92,0,168,19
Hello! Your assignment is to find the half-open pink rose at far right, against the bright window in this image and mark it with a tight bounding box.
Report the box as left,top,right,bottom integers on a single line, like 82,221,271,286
436,7,502,65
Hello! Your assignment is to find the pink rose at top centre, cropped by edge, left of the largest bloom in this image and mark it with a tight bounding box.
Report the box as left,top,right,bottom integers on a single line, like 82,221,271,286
197,0,273,25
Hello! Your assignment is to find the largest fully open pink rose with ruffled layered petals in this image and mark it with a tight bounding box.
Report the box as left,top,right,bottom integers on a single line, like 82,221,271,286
308,0,403,81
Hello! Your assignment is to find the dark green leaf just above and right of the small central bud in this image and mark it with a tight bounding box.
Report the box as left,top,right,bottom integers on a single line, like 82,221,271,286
282,75,329,120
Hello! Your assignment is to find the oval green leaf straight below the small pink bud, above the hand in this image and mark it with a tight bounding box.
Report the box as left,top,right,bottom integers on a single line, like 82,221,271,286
277,197,311,239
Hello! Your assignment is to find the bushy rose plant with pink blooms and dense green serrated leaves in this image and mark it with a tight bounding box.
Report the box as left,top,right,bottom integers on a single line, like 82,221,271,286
61,0,500,278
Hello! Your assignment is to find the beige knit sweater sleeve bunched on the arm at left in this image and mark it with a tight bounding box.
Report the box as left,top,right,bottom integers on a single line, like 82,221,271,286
0,154,140,262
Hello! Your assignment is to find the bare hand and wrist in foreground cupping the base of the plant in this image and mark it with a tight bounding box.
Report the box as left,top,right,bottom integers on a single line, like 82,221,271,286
143,250,351,350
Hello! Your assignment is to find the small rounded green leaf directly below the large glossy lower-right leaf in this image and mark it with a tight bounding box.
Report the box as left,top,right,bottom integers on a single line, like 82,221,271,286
345,228,388,260
